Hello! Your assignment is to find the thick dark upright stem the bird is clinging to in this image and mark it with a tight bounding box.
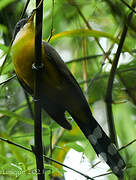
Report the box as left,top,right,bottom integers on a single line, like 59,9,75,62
33,0,45,180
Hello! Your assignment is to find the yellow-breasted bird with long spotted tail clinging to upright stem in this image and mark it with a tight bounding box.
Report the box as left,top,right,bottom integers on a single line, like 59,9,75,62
11,11,126,177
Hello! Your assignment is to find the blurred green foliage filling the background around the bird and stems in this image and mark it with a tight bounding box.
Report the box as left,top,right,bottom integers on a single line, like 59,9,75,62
0,0,136,180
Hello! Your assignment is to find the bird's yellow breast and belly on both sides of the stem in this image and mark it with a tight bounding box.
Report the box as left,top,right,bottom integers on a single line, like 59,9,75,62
11,21,62,95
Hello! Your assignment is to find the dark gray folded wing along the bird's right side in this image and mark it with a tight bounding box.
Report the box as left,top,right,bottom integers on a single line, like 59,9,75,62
43,42,91,121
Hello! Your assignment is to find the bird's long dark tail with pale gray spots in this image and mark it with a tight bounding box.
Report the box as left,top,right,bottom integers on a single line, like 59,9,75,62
76,116,126,177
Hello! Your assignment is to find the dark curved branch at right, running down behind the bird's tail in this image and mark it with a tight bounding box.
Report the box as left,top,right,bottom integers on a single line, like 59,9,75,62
105,9,133,145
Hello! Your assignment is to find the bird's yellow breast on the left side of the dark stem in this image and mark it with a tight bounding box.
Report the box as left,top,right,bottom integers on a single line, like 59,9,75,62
11,28,35,88
